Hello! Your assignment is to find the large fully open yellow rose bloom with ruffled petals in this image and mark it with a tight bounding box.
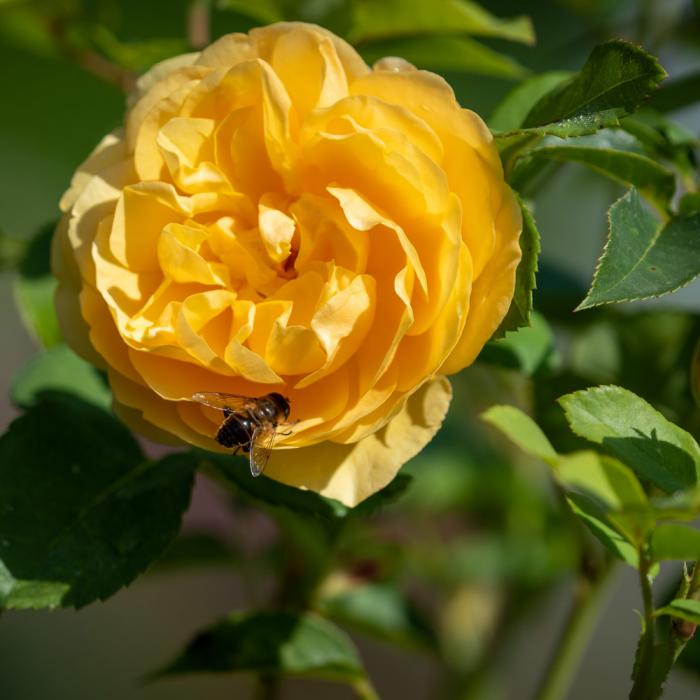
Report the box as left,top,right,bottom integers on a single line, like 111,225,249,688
54,23,521,505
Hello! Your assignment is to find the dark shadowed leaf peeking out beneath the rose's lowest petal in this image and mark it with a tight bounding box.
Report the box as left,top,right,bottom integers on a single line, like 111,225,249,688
202,451,411,523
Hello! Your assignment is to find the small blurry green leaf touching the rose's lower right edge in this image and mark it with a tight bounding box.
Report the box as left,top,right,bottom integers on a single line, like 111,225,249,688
479,311,554,375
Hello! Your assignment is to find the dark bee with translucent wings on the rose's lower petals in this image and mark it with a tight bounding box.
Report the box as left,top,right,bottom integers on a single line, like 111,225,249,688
192,391,291,476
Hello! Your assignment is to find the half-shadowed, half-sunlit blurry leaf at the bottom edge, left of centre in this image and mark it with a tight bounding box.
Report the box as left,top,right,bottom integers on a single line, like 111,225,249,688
157,612,372,684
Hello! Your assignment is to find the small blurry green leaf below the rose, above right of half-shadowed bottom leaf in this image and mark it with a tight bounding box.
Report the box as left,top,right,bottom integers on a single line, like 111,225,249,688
316,583,437,649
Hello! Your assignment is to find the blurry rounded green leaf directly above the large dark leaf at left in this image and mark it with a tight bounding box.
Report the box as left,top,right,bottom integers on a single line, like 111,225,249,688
10,343,112,410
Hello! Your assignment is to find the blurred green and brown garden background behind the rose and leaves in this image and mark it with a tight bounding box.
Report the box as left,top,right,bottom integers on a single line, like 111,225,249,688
0,0,700,700
